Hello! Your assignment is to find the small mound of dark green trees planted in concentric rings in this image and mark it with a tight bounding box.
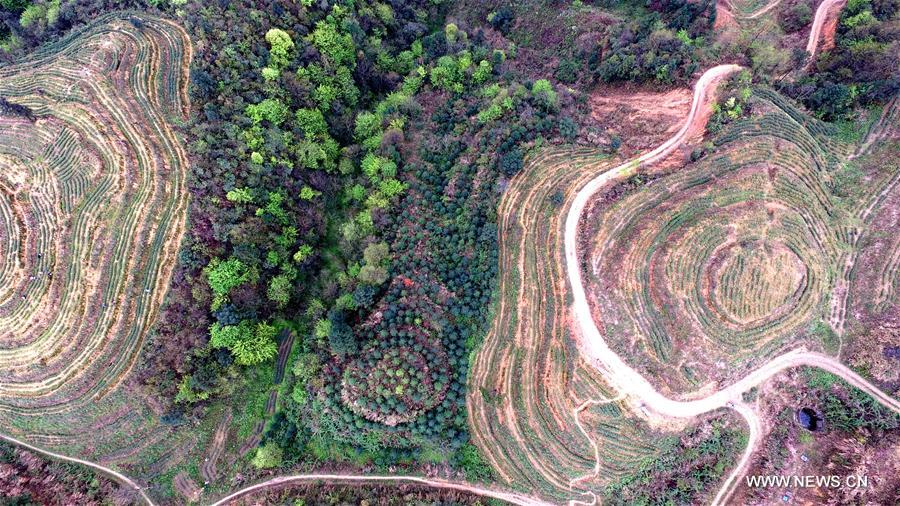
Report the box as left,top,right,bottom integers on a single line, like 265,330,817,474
322,276,469,454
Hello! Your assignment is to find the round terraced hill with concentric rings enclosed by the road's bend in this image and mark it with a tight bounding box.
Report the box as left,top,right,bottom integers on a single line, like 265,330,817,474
582,90,897,395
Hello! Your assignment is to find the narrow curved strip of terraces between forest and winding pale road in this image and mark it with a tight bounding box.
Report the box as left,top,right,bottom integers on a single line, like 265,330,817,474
467,149,684,502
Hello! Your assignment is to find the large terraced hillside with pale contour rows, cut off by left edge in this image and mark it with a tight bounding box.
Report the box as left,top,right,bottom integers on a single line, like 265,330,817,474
0,10,191,486
